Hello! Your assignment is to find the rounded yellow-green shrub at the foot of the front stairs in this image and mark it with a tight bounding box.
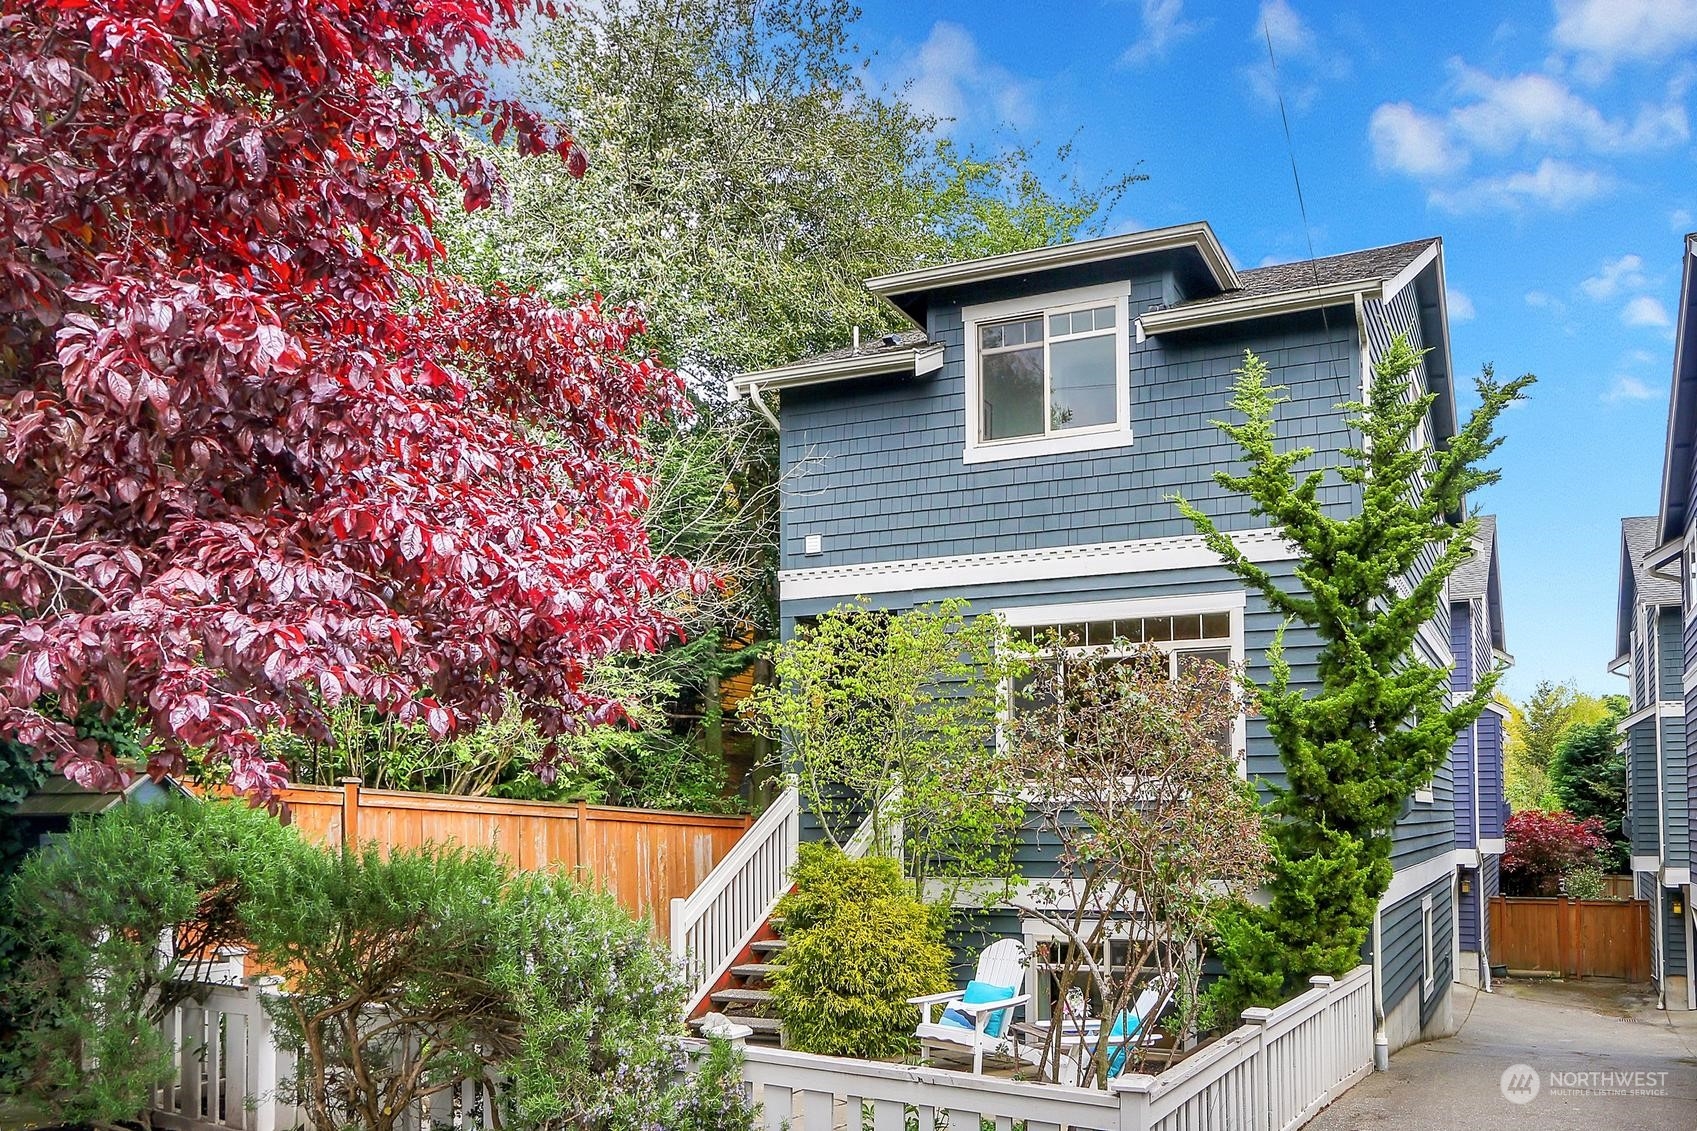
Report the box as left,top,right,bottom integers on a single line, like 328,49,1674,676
772,846,952,1056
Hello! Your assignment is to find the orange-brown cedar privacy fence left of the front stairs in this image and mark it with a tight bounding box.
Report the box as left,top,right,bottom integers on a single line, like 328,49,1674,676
282,781,750,939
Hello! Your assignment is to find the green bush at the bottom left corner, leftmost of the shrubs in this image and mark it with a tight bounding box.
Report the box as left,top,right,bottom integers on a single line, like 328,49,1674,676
0,800,304,1123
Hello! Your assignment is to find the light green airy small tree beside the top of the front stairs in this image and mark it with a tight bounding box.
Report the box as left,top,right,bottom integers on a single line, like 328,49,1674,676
743,599,1028,898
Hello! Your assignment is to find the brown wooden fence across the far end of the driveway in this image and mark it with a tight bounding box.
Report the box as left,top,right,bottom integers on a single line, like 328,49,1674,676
1490,895,1649,982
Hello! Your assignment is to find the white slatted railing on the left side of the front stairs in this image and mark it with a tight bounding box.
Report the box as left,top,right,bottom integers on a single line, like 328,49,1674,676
672,786,801,1016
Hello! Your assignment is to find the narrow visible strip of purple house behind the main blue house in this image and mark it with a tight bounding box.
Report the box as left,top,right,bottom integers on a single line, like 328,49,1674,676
1449,515,1514,987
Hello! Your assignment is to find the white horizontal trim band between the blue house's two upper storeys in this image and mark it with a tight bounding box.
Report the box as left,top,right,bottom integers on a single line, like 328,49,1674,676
777,530,1297,601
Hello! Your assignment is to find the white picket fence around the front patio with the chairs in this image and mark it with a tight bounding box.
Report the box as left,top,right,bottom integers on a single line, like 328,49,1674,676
705,966,1373,1131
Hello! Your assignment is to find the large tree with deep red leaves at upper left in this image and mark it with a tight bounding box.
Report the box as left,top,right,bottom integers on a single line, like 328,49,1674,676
0,0,704,798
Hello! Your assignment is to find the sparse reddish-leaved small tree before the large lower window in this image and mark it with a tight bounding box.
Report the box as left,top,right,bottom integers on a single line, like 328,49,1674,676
1010,645,1269,1083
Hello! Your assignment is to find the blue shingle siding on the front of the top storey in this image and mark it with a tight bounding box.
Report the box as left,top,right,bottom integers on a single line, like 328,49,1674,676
781,268,1359,569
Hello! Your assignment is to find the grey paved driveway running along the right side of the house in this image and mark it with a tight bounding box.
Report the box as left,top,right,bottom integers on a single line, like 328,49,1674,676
1308,982,1697,1131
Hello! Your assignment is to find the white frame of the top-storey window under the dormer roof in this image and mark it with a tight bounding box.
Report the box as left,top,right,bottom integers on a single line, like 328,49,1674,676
961,280,1132,464
